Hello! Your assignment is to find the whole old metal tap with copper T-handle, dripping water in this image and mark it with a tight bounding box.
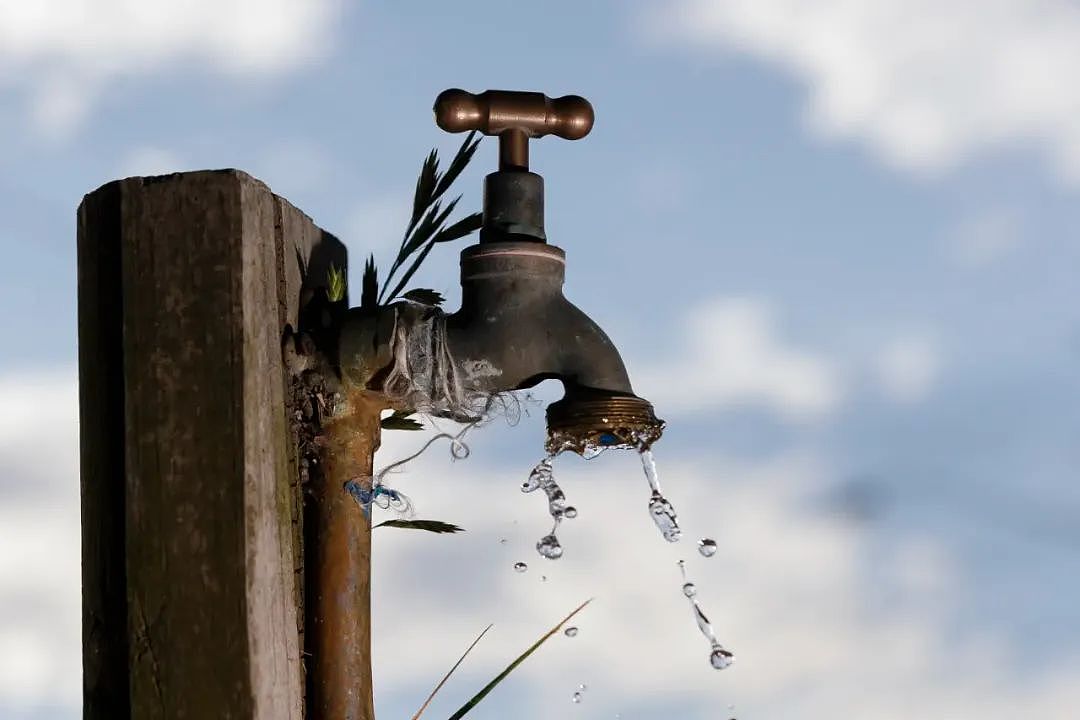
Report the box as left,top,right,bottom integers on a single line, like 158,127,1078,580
342,90,663,453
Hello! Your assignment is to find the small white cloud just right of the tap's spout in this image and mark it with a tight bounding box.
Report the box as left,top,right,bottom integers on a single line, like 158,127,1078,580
634,298,841,420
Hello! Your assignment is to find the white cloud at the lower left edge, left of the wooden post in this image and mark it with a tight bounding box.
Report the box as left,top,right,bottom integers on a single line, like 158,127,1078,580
0,368,82,708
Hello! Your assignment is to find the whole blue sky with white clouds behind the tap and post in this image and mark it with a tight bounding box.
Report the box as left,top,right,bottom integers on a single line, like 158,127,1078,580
0,0,1080,720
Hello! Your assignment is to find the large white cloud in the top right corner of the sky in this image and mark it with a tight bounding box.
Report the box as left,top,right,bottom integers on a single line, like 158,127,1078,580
642,0,1080,181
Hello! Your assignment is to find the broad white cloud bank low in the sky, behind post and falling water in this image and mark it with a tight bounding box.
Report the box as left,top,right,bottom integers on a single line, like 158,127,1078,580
0,368,1080,720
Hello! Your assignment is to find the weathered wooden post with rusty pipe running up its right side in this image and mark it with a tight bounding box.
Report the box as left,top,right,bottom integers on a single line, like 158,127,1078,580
78,171,378,720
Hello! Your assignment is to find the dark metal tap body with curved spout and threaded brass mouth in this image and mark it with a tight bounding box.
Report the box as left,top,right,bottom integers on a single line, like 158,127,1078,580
446,241,663,453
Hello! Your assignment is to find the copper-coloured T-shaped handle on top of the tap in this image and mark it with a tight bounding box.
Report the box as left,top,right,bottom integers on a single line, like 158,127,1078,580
434,87,594,171
